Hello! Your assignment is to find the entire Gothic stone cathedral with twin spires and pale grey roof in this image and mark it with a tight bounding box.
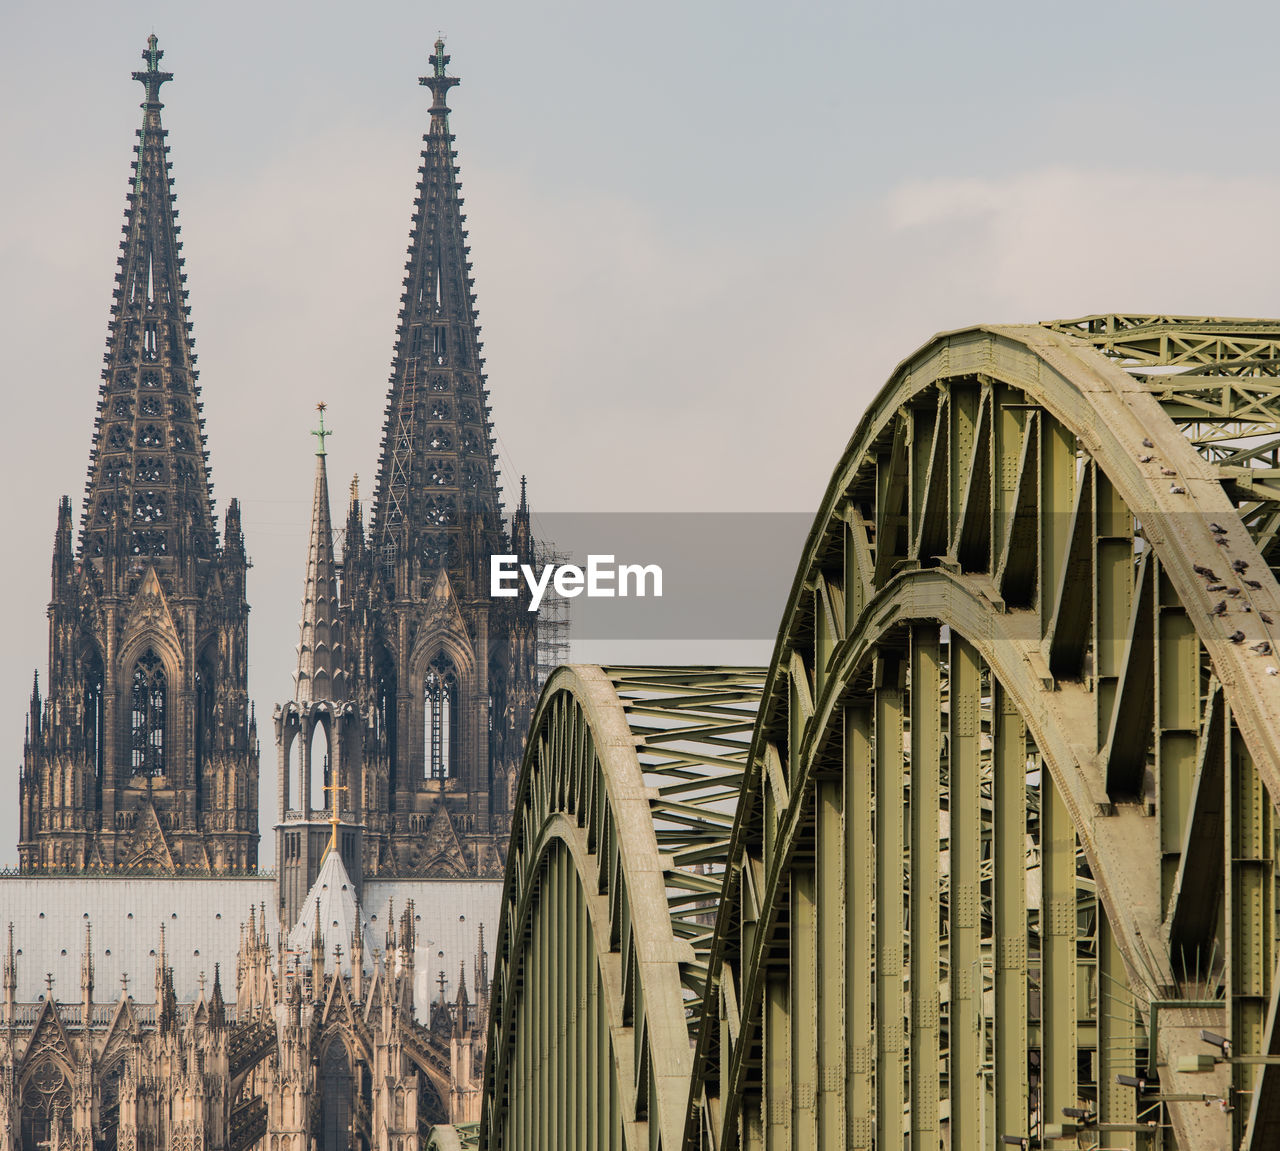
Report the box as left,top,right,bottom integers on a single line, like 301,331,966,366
0,36,539,1151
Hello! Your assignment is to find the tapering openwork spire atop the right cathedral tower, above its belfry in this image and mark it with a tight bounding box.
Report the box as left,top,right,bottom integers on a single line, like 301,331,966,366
372,40,500,586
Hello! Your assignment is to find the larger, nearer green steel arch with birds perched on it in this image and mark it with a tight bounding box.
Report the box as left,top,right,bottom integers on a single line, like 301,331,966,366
686,316,1280,1147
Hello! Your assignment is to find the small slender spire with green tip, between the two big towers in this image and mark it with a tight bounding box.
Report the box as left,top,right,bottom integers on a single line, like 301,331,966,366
293,403,347,703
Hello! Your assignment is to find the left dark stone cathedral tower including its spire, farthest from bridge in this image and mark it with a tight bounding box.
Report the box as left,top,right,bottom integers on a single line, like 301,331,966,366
18,36,257,873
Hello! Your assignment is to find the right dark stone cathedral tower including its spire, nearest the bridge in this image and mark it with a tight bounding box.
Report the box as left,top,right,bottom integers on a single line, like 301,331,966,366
343,41,536,877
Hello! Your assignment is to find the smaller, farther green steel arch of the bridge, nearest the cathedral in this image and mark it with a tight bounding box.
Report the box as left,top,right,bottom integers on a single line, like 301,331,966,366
481,666,764,1148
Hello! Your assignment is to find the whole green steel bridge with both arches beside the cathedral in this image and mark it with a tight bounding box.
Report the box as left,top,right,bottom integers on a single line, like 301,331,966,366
468,315,1280,1151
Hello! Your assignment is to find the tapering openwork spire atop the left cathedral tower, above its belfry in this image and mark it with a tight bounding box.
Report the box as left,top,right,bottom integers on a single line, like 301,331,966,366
81,35,218,566
